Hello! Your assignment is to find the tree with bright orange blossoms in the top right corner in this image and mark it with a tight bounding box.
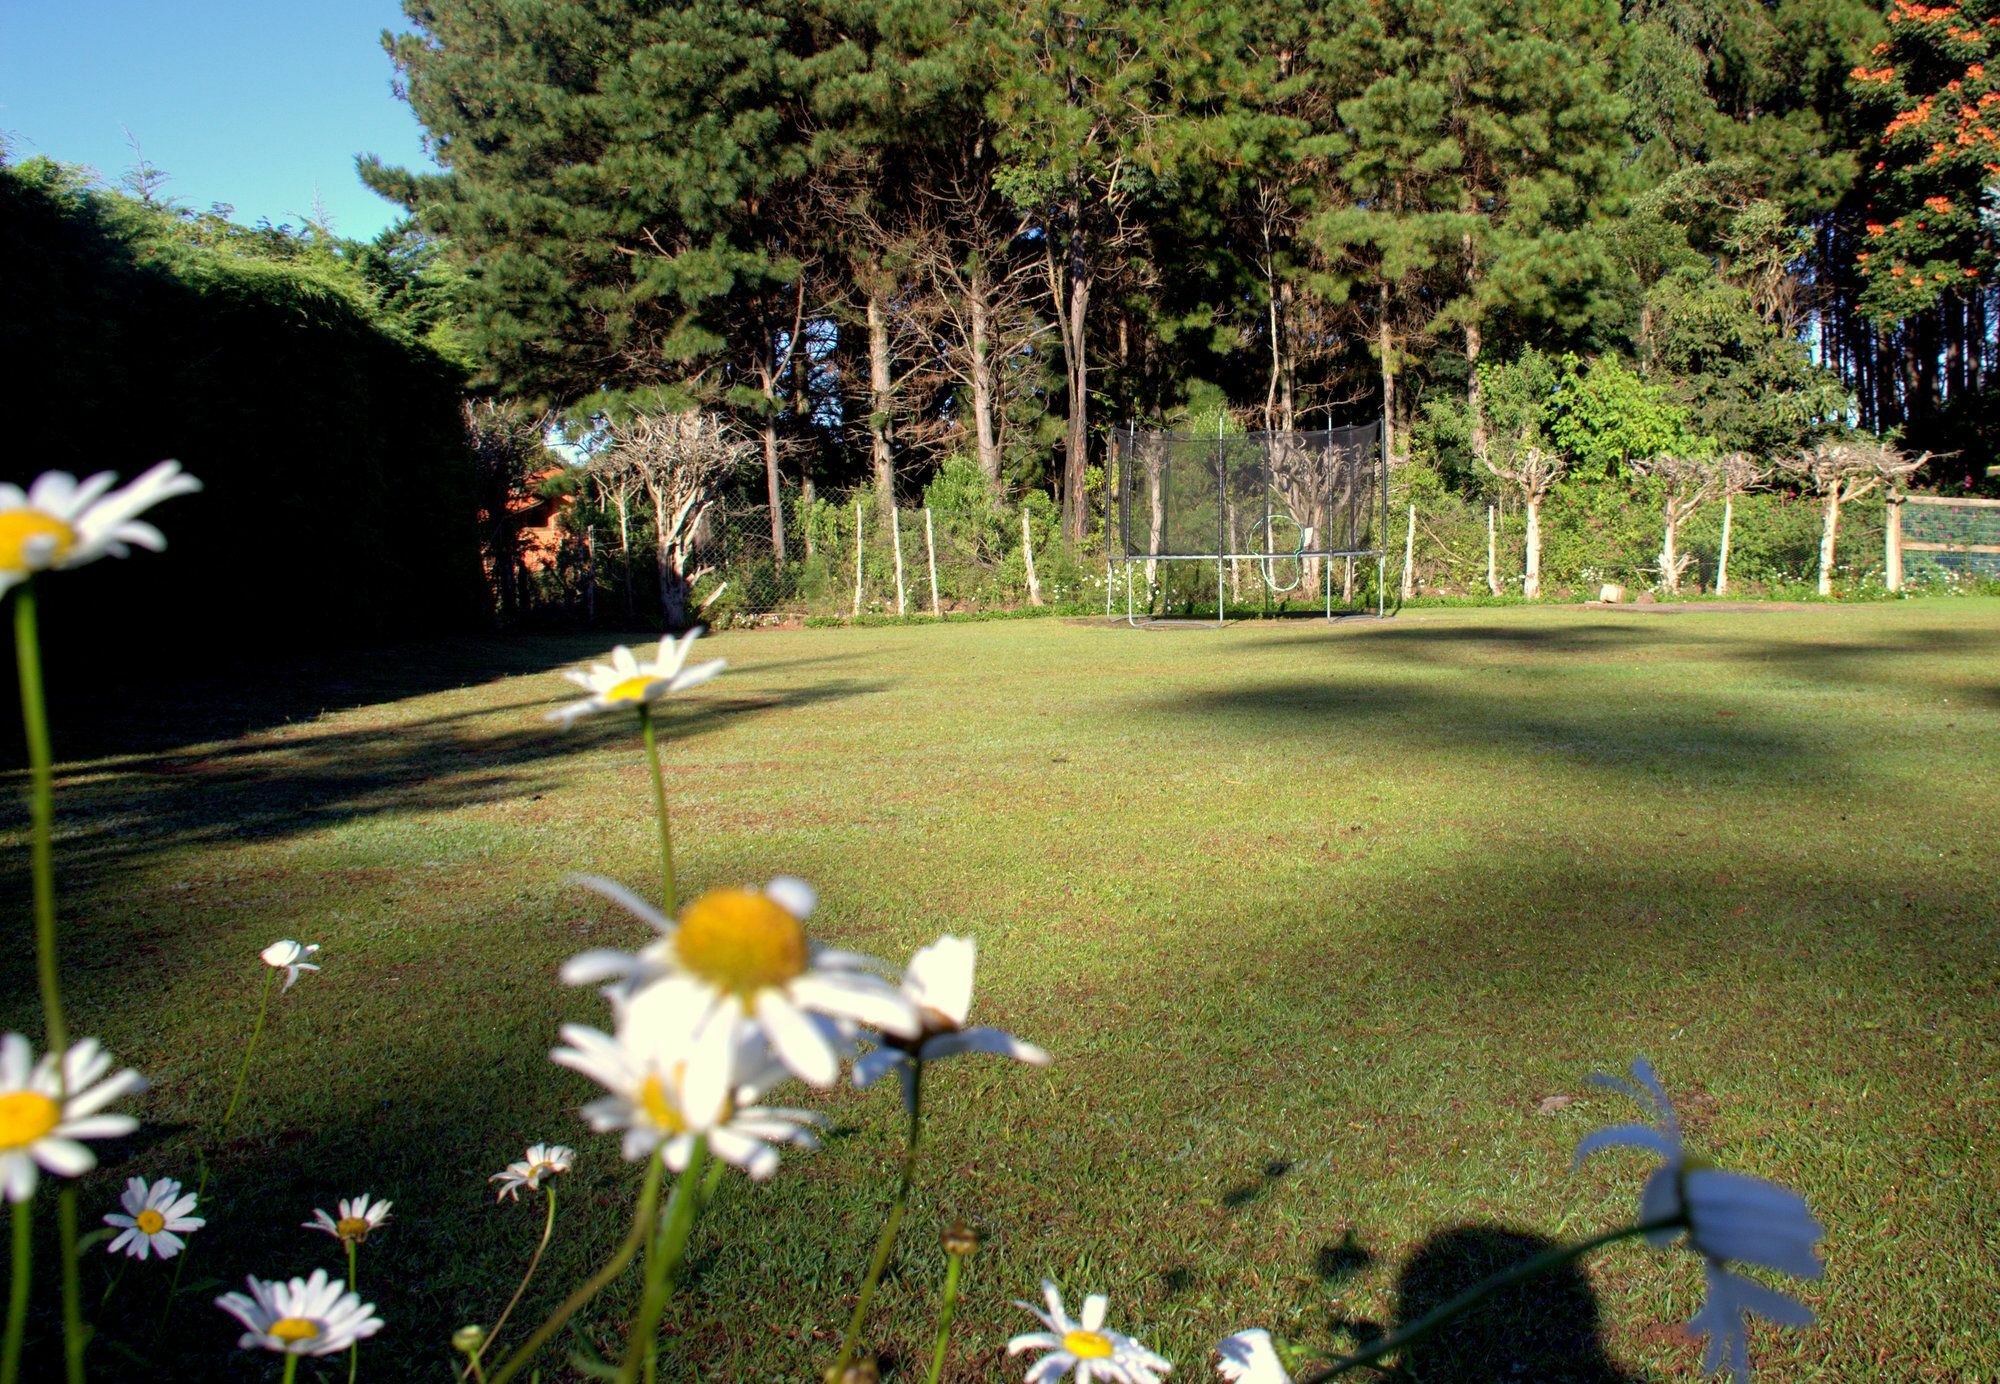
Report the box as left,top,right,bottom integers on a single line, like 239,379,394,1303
1848,0,2000,322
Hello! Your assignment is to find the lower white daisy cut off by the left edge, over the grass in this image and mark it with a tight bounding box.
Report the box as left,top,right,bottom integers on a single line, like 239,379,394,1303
0,1034,146,1202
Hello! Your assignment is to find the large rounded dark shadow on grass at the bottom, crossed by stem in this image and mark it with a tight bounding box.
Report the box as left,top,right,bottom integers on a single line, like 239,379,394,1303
1392,1226,1644,1384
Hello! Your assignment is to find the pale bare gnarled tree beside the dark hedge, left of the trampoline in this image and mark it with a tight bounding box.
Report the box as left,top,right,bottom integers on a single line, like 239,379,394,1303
610,410,752,630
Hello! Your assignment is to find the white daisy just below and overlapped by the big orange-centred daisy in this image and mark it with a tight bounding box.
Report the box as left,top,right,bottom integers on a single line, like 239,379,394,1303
550,986,820,1182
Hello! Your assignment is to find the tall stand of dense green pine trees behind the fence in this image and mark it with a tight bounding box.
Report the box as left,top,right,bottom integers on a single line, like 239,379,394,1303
362,0,2000,584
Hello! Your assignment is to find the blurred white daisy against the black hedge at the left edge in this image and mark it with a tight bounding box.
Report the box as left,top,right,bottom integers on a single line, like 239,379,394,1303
0,462,202,594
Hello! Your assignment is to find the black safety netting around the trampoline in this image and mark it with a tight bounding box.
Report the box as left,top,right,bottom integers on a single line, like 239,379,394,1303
1108,422,1388,556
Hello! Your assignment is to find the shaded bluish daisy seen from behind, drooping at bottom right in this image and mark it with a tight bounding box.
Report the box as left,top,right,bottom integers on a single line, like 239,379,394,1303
1576,1058,1826,1384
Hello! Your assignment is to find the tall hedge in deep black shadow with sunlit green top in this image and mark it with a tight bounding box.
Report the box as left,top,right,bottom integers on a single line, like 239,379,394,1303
0,160,488,664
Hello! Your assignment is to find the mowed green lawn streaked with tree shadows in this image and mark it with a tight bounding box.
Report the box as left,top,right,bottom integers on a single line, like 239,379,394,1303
4,600,2000,1380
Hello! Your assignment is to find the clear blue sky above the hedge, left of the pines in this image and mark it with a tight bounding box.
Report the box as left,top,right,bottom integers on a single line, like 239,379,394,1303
0,0,430,238
